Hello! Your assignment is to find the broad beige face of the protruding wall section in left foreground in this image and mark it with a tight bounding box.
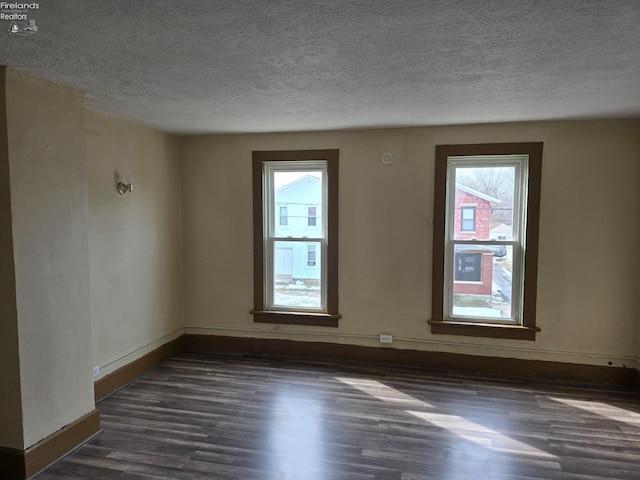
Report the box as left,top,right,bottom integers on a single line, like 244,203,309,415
6,69,94,448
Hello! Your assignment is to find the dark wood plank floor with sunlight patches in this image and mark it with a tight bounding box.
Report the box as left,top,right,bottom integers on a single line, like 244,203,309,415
37,354,640,480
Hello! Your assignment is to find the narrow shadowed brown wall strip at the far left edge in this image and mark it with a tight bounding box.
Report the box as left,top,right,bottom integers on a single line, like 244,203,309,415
0,68,24,448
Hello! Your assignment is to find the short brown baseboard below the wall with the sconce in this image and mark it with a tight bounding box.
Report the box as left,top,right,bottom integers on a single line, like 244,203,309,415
93,335,184,402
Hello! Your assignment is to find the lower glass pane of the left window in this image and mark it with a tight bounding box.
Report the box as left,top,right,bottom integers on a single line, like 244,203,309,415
273,241,322,310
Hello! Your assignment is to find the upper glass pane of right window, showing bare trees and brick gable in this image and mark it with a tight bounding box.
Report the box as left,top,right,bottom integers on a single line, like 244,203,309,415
453,165,516,240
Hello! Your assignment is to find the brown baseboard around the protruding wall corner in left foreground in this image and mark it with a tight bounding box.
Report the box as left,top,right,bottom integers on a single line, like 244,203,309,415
0,410,100,480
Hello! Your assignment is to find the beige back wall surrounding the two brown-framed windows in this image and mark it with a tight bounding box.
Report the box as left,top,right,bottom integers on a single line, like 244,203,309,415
182,120,640,366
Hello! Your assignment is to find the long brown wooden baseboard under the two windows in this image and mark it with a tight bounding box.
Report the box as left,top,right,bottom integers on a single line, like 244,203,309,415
185,334,640,388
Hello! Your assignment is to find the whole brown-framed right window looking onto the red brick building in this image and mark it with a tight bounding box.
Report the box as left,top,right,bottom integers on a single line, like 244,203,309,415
429,143,542,340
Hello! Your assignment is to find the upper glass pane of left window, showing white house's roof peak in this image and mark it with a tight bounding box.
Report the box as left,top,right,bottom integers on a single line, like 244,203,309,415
272,170,322,238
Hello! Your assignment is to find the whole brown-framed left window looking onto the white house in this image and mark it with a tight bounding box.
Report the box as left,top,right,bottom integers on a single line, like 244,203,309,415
251,150,340,327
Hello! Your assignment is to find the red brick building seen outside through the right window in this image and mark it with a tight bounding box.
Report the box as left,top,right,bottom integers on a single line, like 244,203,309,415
453,183,500,295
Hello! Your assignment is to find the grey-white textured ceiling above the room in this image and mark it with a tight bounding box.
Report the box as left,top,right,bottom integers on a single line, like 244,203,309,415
0,0,640,134
